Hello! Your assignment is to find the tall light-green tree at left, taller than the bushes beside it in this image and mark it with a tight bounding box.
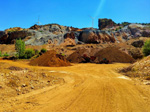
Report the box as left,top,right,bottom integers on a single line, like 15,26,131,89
15,39,25,58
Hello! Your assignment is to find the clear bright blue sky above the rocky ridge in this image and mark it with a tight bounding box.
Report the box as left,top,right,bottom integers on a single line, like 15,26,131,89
0,0,150,30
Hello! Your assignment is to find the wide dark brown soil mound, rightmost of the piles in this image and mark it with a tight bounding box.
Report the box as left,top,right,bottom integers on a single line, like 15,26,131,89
95,47,135,63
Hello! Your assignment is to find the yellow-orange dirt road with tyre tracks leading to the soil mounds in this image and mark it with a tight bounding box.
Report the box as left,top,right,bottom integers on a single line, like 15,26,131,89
0,62,150,112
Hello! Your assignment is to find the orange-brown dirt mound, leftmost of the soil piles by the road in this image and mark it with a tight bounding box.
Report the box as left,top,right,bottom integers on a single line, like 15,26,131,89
29,50,71,67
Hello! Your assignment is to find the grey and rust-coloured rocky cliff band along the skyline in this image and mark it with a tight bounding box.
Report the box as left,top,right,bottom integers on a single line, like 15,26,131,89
0,19,150,46
